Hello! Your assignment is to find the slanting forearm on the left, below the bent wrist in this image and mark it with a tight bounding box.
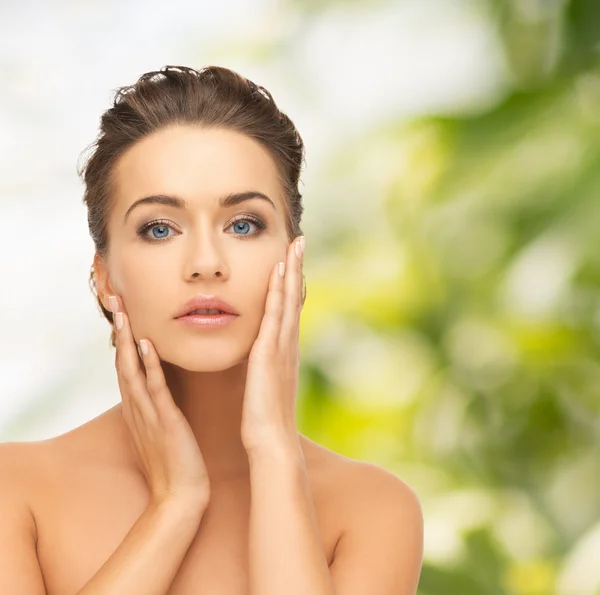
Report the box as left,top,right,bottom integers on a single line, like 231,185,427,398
78,503,203,595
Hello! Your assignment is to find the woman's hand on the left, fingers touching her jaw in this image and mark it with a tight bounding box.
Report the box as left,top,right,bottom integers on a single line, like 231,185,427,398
109,296,210,509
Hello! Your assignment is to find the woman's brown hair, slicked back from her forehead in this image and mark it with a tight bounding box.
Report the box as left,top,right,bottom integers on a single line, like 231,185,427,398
78,66,306,347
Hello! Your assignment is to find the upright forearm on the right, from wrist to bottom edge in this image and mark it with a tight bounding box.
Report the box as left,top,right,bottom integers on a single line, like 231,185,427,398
249,450,334,595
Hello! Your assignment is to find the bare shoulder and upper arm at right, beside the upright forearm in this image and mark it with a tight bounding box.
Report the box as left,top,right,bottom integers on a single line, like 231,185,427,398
302,436,424,595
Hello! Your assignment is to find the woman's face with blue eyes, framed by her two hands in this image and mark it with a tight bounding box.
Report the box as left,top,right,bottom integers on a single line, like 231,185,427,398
94,125,288,371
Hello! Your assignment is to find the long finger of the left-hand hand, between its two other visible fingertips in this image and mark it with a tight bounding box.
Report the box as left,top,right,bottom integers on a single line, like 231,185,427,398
115,311,157,423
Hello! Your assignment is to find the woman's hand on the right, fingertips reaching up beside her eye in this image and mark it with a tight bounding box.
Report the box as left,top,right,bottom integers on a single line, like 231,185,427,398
241,236,304,454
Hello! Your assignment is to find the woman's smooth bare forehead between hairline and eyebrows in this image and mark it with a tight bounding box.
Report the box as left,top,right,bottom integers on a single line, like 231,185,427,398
113,125,282,209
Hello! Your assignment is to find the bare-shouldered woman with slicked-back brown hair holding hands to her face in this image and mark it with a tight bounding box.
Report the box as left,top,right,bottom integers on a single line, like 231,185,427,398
0,66,423,595
